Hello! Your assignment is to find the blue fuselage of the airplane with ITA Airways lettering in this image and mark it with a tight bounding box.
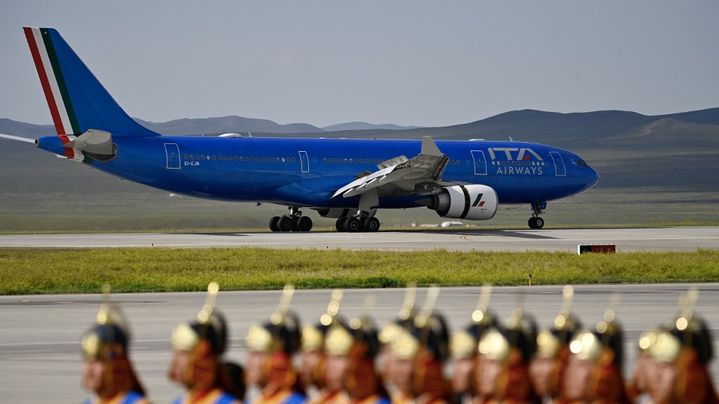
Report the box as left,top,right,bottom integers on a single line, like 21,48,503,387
39,136,598,208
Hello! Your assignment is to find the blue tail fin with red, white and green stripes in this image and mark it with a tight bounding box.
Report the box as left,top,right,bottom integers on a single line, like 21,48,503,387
23,27,159,144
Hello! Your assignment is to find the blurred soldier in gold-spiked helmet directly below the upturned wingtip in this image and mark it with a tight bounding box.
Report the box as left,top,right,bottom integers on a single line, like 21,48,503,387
390,287,450,404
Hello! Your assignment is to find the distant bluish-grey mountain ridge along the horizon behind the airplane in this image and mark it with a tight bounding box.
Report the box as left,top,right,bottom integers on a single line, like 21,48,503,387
0,108,719,144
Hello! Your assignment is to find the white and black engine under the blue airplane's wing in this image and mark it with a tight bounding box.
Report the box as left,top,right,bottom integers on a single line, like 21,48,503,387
429,184,497,220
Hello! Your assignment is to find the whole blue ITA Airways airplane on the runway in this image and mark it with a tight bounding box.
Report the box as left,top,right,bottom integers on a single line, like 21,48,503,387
0,27,599,232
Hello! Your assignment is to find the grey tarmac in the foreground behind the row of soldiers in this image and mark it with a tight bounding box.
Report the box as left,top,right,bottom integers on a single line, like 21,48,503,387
0,284,719,403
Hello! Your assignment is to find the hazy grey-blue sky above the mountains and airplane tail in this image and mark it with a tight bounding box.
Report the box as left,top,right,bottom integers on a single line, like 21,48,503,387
0,0,719,126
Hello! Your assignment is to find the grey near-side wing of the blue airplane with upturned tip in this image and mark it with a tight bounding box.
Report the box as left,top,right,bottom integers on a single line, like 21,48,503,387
332,136,449,198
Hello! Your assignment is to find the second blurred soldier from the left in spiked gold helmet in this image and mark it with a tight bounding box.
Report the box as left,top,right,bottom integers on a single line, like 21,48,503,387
168,282,244,404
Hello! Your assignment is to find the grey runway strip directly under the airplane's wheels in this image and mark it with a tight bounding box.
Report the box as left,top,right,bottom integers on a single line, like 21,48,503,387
0,227,719,252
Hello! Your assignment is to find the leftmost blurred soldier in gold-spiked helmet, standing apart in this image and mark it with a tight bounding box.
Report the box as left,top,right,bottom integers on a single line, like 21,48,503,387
80,287,148,404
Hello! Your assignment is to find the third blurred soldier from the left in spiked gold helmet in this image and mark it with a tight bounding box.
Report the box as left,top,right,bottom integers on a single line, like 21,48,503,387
246,285,305,404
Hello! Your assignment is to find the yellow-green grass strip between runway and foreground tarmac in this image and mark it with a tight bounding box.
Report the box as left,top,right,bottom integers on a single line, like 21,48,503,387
0,248,719,295
